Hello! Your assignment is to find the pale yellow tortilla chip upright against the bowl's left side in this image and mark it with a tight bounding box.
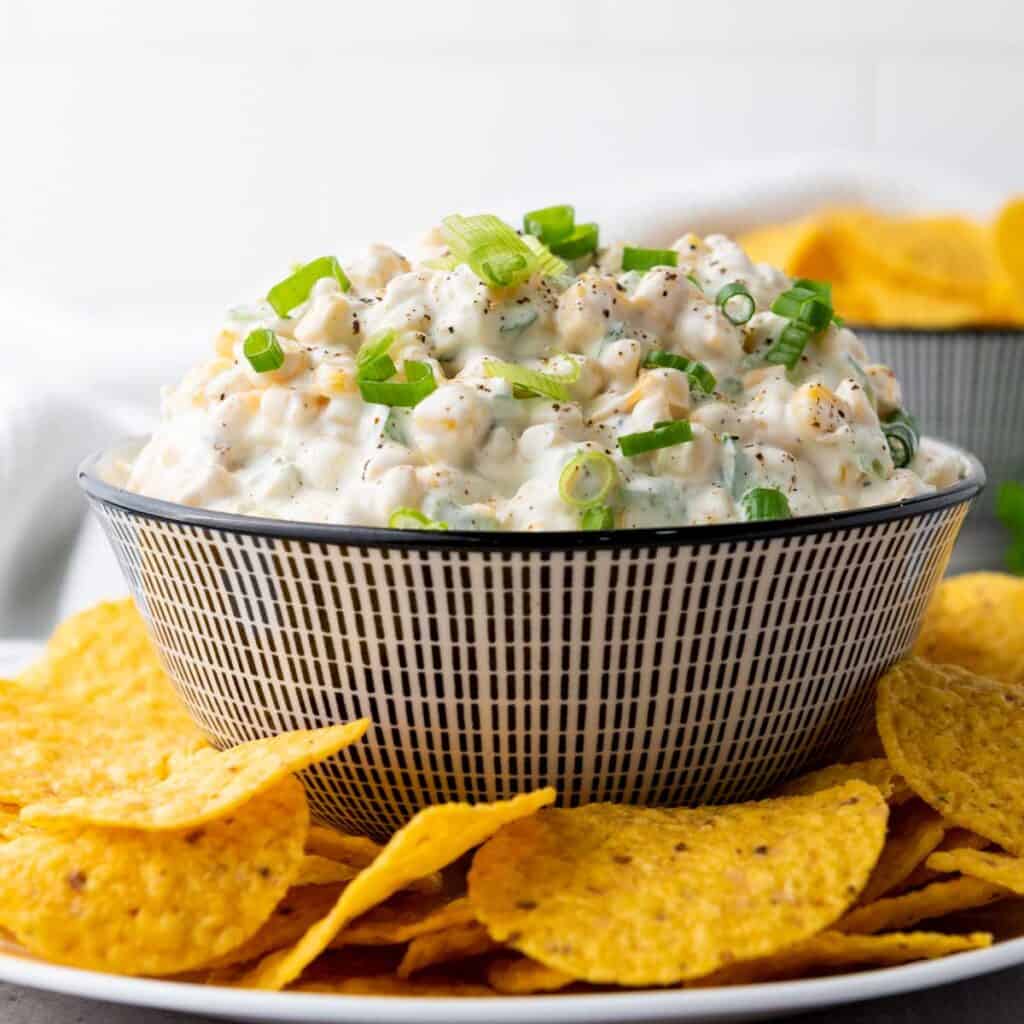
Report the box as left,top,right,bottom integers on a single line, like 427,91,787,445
0,601,206,806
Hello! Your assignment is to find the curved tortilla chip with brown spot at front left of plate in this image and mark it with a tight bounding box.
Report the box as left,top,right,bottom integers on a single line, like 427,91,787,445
0,778,308,975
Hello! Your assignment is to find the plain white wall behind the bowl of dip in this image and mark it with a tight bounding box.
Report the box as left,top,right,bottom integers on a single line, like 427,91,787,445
0,0,1024,368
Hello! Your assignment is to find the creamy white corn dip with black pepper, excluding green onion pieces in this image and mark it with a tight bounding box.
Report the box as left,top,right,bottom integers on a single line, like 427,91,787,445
126,236,962,530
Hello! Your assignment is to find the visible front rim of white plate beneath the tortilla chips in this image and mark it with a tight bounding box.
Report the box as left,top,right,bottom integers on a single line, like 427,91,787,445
0,938,1024,1024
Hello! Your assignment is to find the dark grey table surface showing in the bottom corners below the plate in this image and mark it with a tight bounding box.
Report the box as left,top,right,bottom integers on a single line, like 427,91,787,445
0,968,1024,1024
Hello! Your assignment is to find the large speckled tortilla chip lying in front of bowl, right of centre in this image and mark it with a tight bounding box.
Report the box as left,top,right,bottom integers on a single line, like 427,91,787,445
469,782,887,985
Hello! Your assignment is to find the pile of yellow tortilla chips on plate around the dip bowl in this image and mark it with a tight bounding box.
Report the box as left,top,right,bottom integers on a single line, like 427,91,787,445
0,589,1024,996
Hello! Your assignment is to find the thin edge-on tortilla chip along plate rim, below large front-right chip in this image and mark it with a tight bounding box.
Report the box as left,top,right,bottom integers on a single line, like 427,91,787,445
691,932,992,988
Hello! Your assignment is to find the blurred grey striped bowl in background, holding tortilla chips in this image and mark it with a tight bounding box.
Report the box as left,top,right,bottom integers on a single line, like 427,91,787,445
855,327,1024,521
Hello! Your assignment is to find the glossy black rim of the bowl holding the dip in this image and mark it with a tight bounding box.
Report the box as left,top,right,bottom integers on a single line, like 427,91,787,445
78,442,985,551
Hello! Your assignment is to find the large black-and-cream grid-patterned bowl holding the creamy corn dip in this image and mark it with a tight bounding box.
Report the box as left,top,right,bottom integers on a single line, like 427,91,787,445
80,442,984,836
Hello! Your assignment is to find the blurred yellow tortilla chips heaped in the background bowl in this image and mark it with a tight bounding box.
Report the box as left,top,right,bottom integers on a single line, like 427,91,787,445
740,198,1024,328
